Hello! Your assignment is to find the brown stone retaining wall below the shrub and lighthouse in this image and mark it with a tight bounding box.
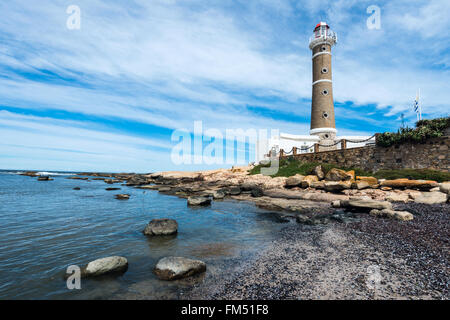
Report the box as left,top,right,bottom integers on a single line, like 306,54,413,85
284,136,450,172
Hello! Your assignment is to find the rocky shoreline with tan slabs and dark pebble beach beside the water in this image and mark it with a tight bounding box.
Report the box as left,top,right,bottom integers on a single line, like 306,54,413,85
22,167,450,299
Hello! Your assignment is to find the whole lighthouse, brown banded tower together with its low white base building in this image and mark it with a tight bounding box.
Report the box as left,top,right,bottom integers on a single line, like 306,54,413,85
255,22,375,161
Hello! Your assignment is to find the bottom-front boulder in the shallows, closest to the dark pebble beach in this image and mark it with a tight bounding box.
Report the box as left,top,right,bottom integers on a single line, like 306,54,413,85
153,257,206,280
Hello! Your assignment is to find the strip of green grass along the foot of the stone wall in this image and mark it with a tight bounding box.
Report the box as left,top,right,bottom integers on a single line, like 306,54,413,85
250,157,450,182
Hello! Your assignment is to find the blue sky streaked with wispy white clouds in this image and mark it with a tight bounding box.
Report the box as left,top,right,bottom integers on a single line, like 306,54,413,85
0,0,450,172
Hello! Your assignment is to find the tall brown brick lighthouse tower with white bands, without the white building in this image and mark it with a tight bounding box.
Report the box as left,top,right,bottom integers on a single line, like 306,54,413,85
309,22,337,151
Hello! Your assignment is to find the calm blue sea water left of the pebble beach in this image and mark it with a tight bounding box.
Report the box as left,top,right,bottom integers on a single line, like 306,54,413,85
0,170,283,299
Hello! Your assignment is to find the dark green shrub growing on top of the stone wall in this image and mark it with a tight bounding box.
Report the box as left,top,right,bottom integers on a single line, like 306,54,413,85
377,117,450,147
